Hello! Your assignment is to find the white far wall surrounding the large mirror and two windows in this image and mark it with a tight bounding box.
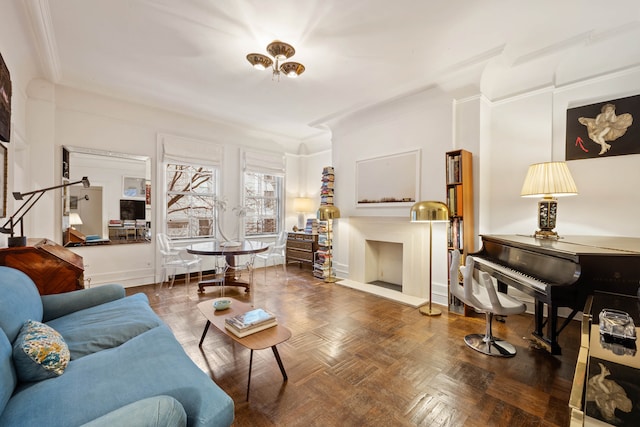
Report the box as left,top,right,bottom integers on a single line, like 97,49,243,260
25,80,320,285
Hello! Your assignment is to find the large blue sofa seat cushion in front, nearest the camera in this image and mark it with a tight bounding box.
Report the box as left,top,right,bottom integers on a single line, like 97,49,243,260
0,325,234,427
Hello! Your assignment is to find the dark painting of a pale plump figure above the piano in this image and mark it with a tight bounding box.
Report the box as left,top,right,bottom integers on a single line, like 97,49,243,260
565,95,640,160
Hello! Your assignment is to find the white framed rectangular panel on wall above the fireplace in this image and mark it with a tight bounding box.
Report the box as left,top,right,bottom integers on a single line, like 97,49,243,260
356,150,420,207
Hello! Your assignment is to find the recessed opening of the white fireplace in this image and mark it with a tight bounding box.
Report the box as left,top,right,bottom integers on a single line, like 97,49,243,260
364,240,402,292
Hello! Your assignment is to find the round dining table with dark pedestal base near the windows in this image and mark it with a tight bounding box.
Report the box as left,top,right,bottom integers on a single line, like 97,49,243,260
185,240,269,292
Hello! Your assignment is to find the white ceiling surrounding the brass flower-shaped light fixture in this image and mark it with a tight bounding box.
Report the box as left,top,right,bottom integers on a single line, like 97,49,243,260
20,0,638,145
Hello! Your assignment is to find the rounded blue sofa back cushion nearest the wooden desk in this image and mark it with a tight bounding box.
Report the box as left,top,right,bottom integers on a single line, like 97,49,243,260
0,266,42,342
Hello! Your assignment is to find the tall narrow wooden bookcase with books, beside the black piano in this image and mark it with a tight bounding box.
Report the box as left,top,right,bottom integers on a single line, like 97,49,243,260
445,150,475,311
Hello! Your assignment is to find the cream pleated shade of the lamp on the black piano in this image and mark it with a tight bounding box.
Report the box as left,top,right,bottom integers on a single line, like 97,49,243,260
520,162,578,197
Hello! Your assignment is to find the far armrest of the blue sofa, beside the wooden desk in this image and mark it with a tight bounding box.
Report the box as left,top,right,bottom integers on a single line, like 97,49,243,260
41,284,125,322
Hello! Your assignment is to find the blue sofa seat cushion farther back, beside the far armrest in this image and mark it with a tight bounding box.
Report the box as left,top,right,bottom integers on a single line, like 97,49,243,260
47,293,162,360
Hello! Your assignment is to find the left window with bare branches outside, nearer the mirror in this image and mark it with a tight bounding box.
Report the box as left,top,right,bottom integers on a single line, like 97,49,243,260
165,163,218,239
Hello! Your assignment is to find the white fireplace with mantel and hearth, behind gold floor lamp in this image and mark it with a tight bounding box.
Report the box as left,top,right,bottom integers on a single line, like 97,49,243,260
338,216,448,307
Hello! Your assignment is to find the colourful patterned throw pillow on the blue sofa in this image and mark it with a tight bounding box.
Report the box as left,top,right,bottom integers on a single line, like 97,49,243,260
13,320,71,382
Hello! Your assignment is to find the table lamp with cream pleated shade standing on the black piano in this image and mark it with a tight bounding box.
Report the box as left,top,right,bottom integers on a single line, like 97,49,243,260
520,162,578,239
